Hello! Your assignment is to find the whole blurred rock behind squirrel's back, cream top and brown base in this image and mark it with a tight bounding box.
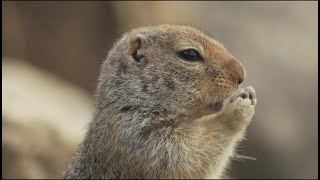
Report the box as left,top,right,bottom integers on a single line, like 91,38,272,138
2,58,92,178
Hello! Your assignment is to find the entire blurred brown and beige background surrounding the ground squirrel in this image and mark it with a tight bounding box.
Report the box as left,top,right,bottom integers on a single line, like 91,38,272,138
2,1,318,179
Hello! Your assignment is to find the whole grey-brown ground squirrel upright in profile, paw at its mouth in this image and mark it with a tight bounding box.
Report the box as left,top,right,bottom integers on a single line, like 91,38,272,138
64,25,256,179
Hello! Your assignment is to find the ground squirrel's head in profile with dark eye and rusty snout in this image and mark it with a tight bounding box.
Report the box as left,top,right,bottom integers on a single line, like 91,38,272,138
98,25,245,118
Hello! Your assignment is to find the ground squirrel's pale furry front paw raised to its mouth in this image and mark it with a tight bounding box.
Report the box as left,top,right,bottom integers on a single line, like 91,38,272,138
224,86,257,125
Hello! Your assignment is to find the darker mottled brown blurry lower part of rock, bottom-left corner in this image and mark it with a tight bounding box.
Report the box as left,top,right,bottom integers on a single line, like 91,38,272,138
2,118,76,178
